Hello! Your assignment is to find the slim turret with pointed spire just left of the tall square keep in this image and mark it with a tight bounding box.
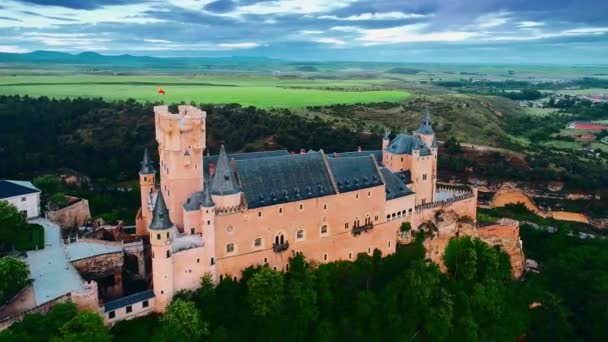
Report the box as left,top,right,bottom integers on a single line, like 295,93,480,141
136,148,156,235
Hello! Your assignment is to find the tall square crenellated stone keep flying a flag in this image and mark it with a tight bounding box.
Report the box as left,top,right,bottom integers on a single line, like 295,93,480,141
154,106,207,230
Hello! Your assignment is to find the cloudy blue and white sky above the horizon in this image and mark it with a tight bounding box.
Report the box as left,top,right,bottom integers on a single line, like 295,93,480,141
0,0,608,64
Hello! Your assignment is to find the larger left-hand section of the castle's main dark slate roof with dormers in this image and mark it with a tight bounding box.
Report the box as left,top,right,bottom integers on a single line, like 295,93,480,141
236,152,335,208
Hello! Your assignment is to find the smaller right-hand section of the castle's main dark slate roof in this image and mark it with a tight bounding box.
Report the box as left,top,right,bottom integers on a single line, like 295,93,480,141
328,156,382,192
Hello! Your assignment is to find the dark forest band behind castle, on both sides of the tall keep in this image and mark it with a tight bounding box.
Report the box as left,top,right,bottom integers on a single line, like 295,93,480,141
0,96,380,181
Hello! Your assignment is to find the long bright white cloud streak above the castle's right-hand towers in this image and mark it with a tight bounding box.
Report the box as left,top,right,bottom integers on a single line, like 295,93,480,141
358,24,477,45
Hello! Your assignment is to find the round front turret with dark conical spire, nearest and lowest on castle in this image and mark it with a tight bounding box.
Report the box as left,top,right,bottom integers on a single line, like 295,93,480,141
150,192,176,312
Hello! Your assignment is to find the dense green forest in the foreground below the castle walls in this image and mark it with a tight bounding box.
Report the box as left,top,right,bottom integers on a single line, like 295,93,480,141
0,219,608,341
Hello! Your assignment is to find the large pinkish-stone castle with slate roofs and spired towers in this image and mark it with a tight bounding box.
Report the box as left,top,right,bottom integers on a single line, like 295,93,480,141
136,106,477,312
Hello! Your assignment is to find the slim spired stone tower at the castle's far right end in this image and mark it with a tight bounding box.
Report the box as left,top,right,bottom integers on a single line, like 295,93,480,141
412,108,437,205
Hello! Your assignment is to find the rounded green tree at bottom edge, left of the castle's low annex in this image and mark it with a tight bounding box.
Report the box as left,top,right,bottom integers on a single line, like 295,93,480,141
51,311,112,342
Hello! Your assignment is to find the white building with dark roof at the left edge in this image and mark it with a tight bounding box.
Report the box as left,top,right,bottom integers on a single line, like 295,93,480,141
0,180,40,219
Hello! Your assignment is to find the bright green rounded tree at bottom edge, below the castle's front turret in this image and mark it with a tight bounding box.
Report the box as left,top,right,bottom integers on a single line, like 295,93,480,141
161,299,209,341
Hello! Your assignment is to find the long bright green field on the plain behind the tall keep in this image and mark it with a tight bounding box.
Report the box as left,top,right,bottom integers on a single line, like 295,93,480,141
0,75,411,108
